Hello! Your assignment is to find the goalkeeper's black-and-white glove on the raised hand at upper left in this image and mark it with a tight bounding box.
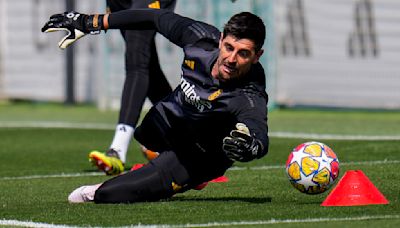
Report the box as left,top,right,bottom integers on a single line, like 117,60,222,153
42,11,104,49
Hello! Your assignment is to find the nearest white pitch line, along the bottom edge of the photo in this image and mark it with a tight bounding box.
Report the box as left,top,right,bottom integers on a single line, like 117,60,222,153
0,215,400,228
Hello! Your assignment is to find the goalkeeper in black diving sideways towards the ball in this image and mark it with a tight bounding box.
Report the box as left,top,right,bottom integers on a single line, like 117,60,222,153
42,10,269,203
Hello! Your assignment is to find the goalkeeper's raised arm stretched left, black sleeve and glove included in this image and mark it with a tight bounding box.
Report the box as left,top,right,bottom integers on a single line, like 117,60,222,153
42,9,220,49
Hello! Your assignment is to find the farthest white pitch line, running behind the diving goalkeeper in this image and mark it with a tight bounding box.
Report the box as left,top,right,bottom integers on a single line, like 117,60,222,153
0,121,400,141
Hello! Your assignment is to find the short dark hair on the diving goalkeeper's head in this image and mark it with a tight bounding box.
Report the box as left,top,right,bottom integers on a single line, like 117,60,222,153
223,12,265,51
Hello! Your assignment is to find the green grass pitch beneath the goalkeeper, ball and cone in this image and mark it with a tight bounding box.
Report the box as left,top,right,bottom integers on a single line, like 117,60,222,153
0,104,400,227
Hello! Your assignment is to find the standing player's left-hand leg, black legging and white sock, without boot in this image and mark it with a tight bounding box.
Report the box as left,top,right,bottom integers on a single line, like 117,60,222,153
110,31,155,162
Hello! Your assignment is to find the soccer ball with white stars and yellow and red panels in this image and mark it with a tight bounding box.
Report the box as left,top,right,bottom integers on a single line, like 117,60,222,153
286,142,339,194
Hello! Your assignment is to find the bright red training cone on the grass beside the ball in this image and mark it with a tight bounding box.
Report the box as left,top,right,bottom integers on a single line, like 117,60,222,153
321,170,389,206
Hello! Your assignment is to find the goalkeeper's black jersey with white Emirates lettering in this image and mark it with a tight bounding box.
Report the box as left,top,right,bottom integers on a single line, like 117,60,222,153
109,10,268,162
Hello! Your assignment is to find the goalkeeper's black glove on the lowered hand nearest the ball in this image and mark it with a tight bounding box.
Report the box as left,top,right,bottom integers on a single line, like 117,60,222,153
222,123,263,162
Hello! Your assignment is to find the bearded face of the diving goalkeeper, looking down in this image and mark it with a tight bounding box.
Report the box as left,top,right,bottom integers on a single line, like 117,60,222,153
211,35,263,81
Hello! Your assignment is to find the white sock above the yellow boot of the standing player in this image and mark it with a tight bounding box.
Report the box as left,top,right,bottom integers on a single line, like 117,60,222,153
110,124,135,163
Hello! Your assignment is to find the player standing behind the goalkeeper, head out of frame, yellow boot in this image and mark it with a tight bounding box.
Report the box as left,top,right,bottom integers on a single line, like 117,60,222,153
89,0,176,175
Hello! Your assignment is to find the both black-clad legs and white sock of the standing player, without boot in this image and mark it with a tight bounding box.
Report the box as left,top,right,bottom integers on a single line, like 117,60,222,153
110,0,175,162
